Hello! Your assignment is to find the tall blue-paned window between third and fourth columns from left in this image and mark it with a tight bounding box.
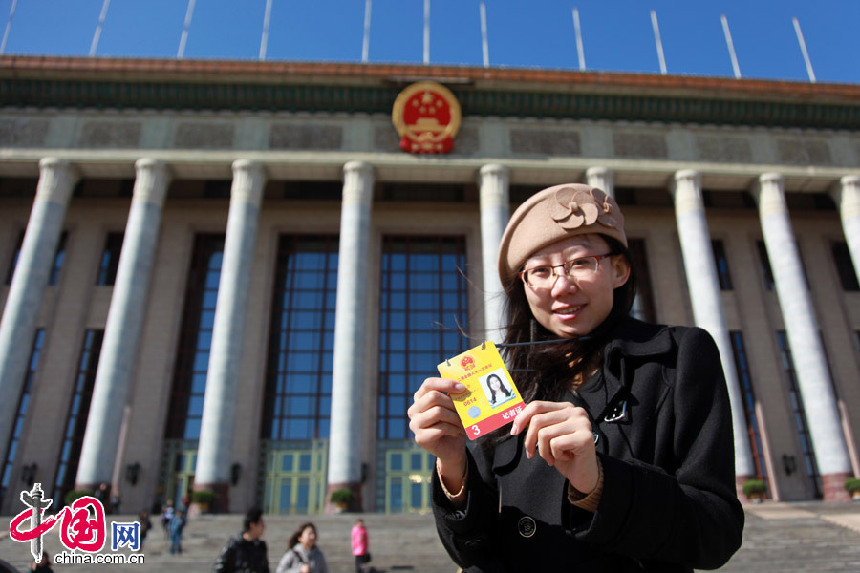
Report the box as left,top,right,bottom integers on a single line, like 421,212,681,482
261,235,338,440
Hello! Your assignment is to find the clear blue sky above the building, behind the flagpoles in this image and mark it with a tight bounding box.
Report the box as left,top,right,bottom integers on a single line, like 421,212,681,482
0,0,860,83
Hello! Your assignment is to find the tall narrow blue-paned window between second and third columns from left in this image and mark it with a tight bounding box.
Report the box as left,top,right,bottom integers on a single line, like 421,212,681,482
165,235,224,440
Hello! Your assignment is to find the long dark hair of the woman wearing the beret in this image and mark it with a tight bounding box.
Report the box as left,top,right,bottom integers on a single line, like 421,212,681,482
502,235,636,402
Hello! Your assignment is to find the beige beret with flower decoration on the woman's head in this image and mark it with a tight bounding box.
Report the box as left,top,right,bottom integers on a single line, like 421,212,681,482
499,183,627,282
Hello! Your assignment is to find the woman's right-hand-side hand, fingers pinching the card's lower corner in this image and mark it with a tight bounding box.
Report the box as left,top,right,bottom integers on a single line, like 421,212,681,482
511,400,599,494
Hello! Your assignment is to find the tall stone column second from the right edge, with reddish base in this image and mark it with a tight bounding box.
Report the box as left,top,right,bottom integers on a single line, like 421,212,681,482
753,173,851,500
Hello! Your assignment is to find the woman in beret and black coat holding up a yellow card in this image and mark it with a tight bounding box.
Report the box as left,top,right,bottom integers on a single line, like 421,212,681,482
409,184,743,572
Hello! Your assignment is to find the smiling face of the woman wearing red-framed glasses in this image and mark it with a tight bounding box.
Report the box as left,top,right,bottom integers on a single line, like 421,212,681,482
523,234,630,338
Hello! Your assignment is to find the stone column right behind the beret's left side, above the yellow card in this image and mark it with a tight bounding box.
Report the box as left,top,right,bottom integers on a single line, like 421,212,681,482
479,164,511,344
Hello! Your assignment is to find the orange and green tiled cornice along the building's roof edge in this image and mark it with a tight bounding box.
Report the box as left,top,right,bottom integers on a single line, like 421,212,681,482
0,56,860,131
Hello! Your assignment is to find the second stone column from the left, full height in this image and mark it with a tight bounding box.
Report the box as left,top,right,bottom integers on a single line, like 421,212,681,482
75,159,170,490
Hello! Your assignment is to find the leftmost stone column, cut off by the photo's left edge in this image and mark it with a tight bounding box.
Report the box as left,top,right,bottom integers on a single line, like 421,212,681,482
0,158,77,470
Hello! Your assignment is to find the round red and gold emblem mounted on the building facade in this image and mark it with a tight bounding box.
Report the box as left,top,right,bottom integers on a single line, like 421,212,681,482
391,82,462,153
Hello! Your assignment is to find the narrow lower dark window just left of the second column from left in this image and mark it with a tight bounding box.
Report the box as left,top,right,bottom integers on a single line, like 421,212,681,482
53,330,104,508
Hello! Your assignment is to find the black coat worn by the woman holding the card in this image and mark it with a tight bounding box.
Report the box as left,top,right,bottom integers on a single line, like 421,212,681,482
433,319,744,572
